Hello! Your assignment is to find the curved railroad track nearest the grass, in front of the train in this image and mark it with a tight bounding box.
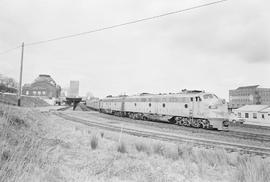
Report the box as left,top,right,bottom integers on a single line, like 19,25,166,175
53,112,270,156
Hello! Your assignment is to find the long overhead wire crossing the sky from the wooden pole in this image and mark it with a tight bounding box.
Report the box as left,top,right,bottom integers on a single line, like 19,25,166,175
0,0,228,55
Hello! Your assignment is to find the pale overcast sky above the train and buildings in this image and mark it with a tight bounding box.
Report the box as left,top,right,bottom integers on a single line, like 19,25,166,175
0,0,270,99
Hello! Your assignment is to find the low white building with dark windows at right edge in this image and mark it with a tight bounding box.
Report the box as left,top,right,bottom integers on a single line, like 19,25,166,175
233,105,270,125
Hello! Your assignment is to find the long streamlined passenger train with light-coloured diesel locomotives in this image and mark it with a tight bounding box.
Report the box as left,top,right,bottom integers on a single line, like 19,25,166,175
86,90,229,130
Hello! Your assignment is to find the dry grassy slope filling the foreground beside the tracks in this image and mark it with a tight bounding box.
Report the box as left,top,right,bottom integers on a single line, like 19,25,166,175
0,106,270,182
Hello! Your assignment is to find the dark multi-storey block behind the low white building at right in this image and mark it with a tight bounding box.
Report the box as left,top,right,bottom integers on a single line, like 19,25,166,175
229,85,270,109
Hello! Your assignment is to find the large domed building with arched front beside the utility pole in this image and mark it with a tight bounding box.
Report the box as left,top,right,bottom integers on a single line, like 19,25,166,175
22,74,61,99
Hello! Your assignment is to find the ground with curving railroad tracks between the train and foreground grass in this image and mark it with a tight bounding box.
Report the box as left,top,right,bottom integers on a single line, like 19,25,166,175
50,104,270,157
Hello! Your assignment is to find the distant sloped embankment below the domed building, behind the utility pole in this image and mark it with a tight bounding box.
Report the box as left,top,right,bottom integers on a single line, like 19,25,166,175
0,92,49,107
